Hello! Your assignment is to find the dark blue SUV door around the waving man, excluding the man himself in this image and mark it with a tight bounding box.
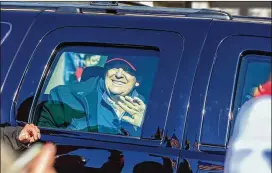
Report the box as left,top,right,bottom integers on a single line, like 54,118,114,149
10,13,194,172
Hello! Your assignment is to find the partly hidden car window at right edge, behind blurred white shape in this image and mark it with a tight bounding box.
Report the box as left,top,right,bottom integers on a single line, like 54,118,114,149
232,54,272,134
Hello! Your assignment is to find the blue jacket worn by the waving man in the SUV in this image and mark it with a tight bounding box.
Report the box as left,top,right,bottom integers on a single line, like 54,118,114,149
38,77,143,137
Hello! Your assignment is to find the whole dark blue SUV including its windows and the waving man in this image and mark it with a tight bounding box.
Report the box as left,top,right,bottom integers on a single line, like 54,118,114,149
1,2,272,173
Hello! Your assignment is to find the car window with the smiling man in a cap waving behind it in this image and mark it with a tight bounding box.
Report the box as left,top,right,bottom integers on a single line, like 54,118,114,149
35,46,158,137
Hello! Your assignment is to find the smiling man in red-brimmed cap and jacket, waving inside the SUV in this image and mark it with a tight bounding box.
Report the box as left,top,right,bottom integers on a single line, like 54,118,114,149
38,58,146,136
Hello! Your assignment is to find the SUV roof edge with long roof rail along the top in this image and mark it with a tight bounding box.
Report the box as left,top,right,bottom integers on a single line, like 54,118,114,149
1,1,272,24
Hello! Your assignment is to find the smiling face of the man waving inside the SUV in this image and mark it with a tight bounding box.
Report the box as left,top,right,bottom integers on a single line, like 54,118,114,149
105,68,136,96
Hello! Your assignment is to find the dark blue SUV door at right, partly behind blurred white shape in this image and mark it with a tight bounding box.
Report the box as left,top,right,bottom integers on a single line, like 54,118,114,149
181,19,272,172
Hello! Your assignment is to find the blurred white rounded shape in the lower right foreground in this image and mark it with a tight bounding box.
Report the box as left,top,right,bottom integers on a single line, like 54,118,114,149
225,96,271,173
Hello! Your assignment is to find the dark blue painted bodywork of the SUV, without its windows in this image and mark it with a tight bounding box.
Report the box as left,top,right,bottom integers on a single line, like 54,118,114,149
1,3,272,173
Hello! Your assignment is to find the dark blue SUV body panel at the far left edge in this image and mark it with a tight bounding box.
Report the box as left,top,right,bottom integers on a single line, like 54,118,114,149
0,8,40,123
